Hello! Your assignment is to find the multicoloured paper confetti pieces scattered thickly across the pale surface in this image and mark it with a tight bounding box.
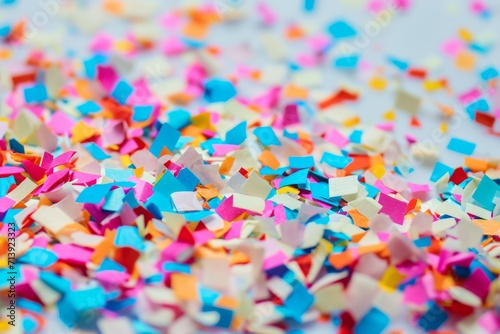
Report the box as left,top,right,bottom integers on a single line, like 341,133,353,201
0,0,500,334
